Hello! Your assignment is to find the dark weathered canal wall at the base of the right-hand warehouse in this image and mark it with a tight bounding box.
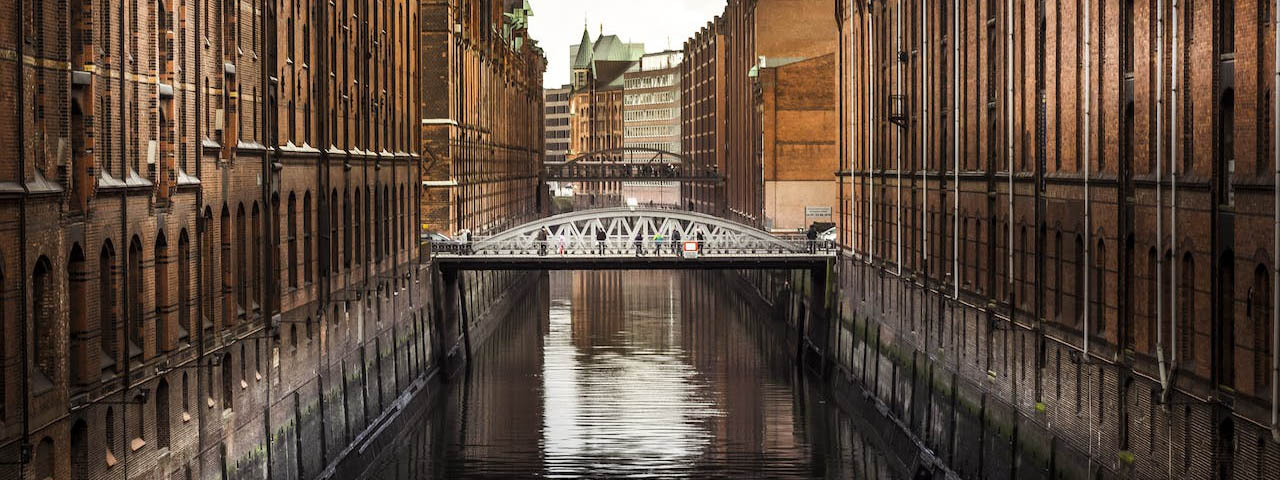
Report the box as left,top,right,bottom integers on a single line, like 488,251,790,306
798,257,1280,479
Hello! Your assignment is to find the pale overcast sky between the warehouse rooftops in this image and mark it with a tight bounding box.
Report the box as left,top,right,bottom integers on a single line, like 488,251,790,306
529,0,724,88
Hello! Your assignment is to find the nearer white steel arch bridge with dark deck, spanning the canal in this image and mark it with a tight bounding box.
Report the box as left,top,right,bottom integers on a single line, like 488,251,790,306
434,207,836,270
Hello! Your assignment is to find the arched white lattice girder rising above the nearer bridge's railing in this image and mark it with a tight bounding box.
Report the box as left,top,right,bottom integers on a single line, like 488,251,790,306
472,207,805,253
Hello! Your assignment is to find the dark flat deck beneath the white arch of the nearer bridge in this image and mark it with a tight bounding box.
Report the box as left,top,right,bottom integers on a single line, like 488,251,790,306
435,252,835,270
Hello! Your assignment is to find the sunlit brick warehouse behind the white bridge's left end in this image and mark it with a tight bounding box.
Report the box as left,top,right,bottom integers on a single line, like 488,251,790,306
421,0,547,233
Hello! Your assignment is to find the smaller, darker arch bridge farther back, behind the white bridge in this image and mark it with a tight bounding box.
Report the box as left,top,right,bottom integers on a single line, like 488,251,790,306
543,147,721,182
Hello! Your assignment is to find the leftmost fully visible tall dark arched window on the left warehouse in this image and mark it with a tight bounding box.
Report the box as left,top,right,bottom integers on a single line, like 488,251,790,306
31,256,60,393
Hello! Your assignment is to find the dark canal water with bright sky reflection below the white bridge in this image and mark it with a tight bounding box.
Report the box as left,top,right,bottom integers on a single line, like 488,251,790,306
360,271,895,480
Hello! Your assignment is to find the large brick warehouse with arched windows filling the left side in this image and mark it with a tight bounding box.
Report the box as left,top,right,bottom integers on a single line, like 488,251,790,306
0,0,440,479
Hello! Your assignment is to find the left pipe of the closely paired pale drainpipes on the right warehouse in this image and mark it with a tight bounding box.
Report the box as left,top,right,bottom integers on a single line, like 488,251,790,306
1147,0,1167,389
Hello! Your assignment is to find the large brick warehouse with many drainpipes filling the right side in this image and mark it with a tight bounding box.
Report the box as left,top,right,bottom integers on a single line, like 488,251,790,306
835,0,1280,479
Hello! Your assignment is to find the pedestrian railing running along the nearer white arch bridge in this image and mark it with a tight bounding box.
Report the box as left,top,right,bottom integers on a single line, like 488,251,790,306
431,236,837,257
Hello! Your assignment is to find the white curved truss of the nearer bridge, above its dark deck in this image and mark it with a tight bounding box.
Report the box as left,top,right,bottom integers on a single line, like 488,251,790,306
462,207,833,256
